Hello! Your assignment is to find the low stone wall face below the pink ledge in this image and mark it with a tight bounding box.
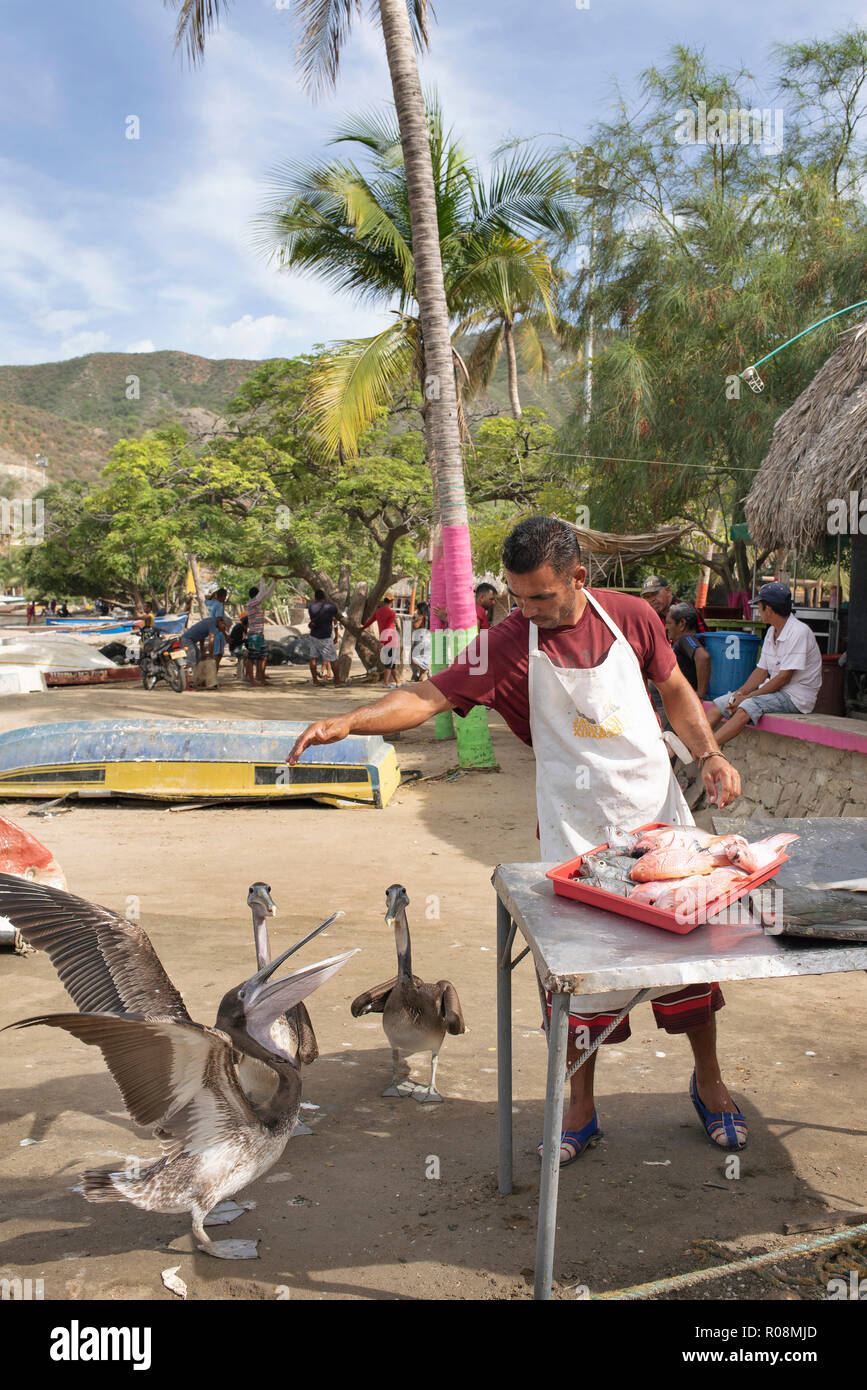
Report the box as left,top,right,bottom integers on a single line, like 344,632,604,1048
724,728,867,816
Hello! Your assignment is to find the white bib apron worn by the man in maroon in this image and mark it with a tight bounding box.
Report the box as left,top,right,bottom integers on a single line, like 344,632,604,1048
528,591,695,1013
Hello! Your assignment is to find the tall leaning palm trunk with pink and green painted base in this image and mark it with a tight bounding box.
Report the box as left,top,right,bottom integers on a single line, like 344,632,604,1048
378,0,495,766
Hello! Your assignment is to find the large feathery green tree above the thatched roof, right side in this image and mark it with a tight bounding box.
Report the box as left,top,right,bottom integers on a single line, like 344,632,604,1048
563,31,867,589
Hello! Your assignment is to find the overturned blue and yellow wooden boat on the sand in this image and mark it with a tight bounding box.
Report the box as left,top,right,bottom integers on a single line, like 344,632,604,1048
0,719,400,808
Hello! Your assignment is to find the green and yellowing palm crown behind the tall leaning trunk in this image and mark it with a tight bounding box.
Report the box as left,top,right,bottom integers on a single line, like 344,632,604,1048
261,100,574,453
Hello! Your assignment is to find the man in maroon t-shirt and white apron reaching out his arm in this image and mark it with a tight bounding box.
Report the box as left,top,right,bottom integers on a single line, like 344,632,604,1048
286,517,746,1162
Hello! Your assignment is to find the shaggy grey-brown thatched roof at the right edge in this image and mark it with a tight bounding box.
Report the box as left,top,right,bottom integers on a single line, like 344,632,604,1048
745,322,867,552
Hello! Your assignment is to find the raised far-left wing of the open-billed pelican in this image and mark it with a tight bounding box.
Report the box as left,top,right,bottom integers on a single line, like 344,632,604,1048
0,873,190,1022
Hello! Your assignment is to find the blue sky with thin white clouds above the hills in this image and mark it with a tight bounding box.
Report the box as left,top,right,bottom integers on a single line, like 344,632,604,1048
0,0,853,363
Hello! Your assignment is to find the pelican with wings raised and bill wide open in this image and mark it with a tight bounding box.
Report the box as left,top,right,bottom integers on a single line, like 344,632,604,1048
0,874,354,1259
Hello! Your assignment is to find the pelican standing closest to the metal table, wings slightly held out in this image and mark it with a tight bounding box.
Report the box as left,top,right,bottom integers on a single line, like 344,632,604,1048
350,883,467,1104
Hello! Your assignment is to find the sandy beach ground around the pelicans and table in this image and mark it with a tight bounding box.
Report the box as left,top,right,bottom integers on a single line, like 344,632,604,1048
0,670,867,1300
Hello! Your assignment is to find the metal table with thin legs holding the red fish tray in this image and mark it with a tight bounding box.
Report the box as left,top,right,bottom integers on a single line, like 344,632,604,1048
492,861,867,1298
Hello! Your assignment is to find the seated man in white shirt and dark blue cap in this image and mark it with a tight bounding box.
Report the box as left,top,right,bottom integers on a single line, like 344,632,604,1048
707,582,821,746
